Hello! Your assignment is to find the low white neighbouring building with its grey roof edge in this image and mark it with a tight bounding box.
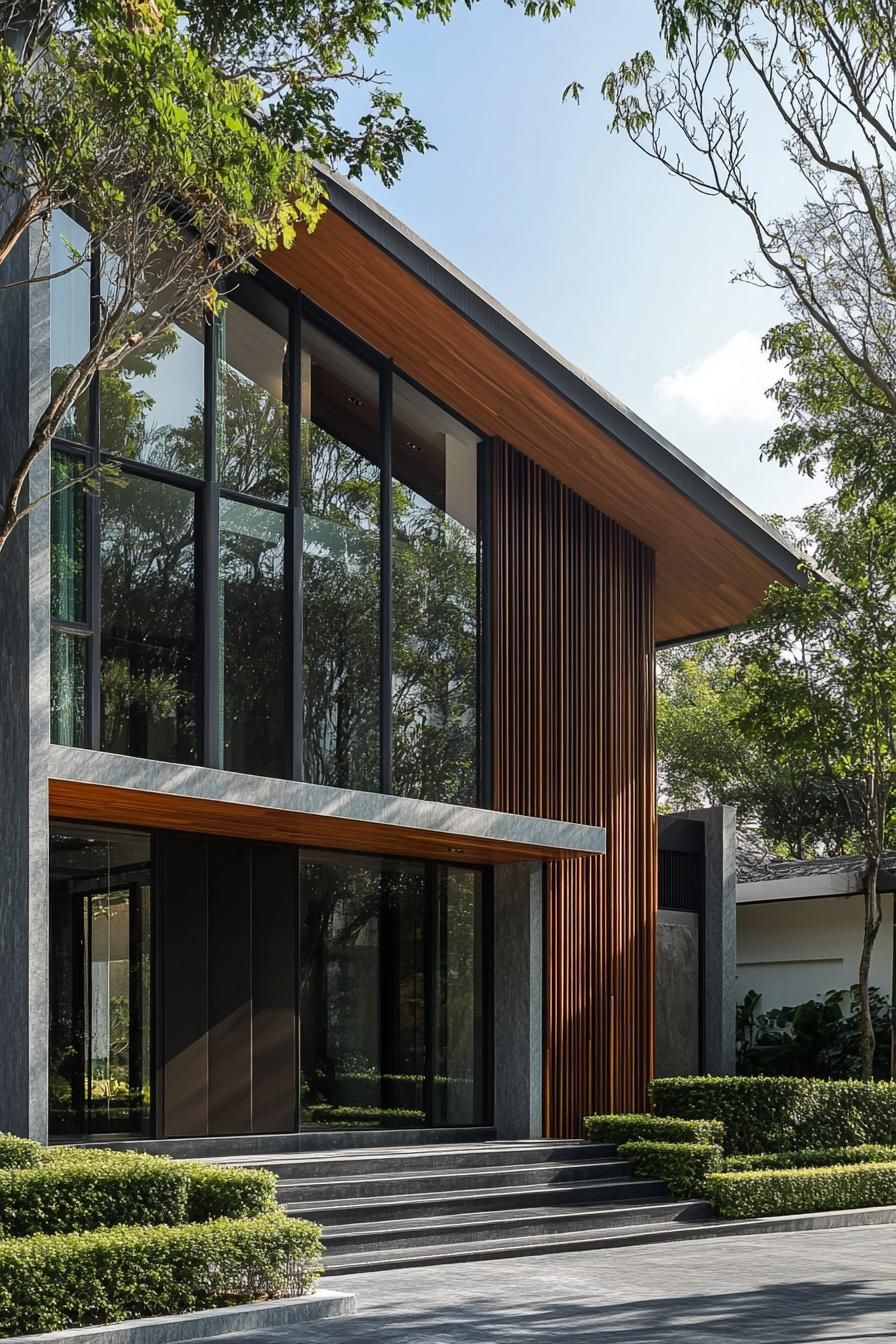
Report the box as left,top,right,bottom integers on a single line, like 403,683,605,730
737,847,896,1012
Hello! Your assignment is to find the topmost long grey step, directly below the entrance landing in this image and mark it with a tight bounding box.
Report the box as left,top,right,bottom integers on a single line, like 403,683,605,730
216,1138,615,1180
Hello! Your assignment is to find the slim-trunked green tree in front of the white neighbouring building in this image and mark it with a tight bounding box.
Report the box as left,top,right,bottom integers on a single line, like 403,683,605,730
739,500,896,1078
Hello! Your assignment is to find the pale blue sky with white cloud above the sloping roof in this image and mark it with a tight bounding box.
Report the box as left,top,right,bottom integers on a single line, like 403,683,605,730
346,0,821,513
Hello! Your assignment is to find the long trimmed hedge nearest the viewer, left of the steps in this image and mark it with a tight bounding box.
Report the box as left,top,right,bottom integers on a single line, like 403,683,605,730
0,1214,321,1335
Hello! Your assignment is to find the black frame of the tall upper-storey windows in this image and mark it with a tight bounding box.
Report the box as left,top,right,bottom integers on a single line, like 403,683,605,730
51,247,492,806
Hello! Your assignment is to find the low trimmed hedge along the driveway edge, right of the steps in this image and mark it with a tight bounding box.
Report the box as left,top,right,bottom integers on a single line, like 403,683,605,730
707,1163,896,1218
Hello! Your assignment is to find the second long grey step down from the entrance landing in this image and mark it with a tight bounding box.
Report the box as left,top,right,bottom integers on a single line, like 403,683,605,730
277,1159,631,1207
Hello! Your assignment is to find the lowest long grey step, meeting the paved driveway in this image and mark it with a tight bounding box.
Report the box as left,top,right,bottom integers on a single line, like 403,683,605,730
325,1200,719,1284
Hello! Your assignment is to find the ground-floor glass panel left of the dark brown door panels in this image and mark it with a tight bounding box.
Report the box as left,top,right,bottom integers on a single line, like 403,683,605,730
50,824,152,1134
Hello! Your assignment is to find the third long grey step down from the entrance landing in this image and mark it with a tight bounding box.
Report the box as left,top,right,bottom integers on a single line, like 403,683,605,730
291,1175,666,1227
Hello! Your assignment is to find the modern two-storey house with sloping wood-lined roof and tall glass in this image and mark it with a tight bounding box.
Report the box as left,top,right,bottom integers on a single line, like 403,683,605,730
0,179,798,1144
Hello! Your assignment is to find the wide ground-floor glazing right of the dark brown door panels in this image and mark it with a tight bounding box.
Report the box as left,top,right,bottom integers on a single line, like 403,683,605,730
300,851,488,1129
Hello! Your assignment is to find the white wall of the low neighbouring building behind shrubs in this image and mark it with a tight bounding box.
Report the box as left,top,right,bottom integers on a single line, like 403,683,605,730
737,880,893,1011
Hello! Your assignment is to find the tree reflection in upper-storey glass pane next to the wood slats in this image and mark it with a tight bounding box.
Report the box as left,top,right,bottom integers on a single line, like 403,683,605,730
392,484,478,804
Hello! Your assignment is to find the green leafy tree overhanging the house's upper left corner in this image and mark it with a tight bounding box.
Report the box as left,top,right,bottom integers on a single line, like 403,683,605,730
0,0,575,550
